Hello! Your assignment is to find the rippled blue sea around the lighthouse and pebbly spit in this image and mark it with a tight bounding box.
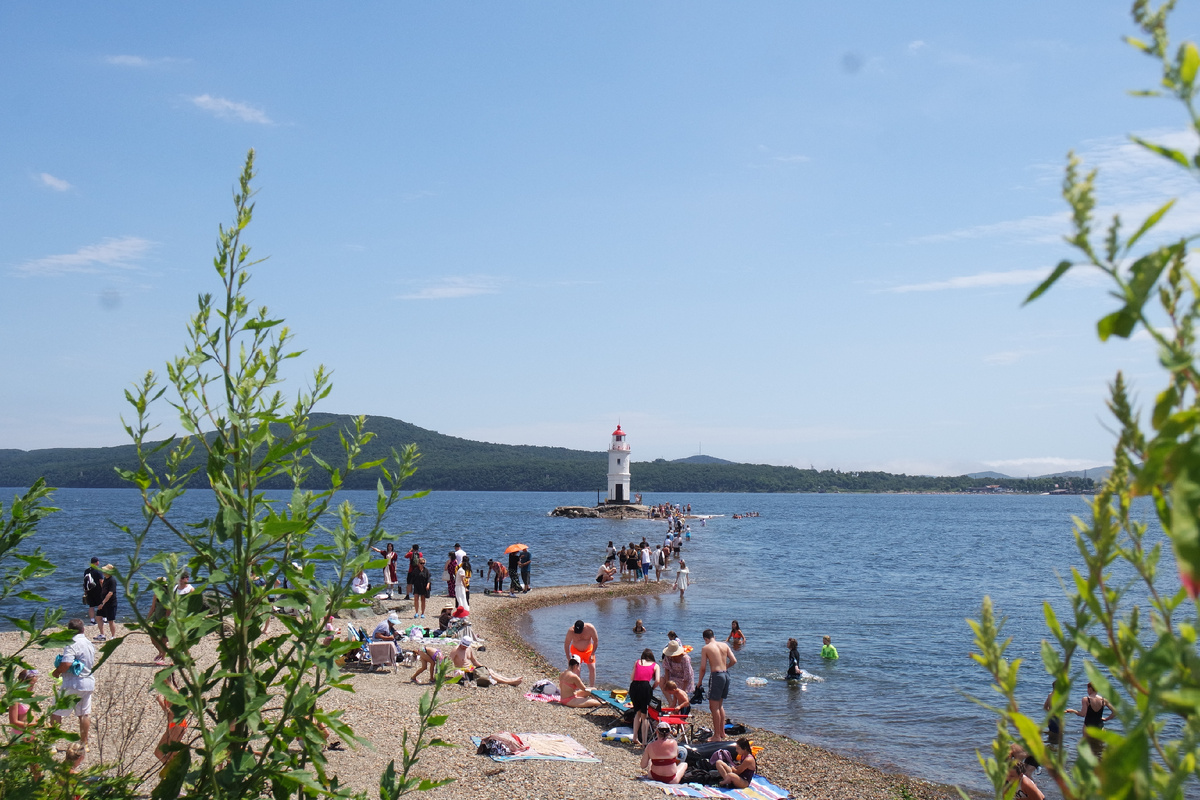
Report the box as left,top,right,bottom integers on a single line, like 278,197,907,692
0,489,1176,790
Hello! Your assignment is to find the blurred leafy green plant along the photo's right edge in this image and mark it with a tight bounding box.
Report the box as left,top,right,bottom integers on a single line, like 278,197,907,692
971,0,1200,799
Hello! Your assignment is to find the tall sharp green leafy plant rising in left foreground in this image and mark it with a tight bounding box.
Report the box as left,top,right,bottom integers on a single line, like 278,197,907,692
104,151,439,799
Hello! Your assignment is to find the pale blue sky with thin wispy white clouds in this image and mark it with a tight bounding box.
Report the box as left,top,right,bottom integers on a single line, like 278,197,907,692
0,0,1200,474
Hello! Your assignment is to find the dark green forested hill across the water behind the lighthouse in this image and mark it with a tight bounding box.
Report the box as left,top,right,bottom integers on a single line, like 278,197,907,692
0,414,1091,493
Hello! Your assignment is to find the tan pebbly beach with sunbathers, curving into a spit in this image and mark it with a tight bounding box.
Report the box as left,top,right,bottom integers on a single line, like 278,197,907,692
0,584,958,800
